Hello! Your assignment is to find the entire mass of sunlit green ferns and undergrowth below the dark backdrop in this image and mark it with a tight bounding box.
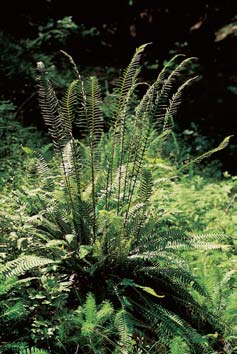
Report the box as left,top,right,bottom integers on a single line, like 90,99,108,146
0,45,237,354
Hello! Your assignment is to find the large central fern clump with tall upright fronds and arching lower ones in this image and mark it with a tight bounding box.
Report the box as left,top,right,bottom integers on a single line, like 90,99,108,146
8,45,231,353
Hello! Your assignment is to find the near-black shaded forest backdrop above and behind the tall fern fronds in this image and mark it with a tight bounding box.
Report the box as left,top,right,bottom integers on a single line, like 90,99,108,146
0,0,237,173
